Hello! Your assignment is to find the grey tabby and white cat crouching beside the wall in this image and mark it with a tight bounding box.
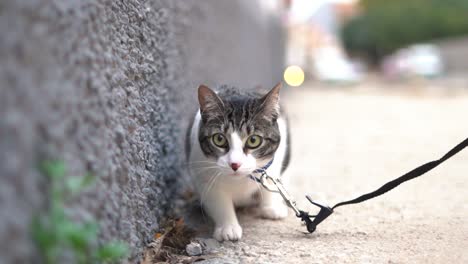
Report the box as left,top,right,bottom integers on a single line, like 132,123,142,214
186,83,290,241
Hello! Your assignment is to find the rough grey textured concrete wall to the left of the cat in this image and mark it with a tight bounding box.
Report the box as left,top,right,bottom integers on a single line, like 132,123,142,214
0,0,283,263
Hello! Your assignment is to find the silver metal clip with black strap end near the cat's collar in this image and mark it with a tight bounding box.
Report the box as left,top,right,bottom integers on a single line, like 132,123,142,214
260,171,333,233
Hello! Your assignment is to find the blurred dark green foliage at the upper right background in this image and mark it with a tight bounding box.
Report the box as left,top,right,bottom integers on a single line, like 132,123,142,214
341,0,468,63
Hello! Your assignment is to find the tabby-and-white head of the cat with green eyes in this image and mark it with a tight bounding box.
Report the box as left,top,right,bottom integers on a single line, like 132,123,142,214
198,83,281,177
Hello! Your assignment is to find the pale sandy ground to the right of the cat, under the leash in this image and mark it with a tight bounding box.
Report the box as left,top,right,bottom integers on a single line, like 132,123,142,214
186,79,468,263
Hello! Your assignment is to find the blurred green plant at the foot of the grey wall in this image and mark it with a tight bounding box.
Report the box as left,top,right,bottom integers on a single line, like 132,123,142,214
31,161,128,264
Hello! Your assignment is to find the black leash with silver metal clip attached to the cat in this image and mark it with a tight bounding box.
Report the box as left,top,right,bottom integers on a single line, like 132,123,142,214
251,138,468,233
